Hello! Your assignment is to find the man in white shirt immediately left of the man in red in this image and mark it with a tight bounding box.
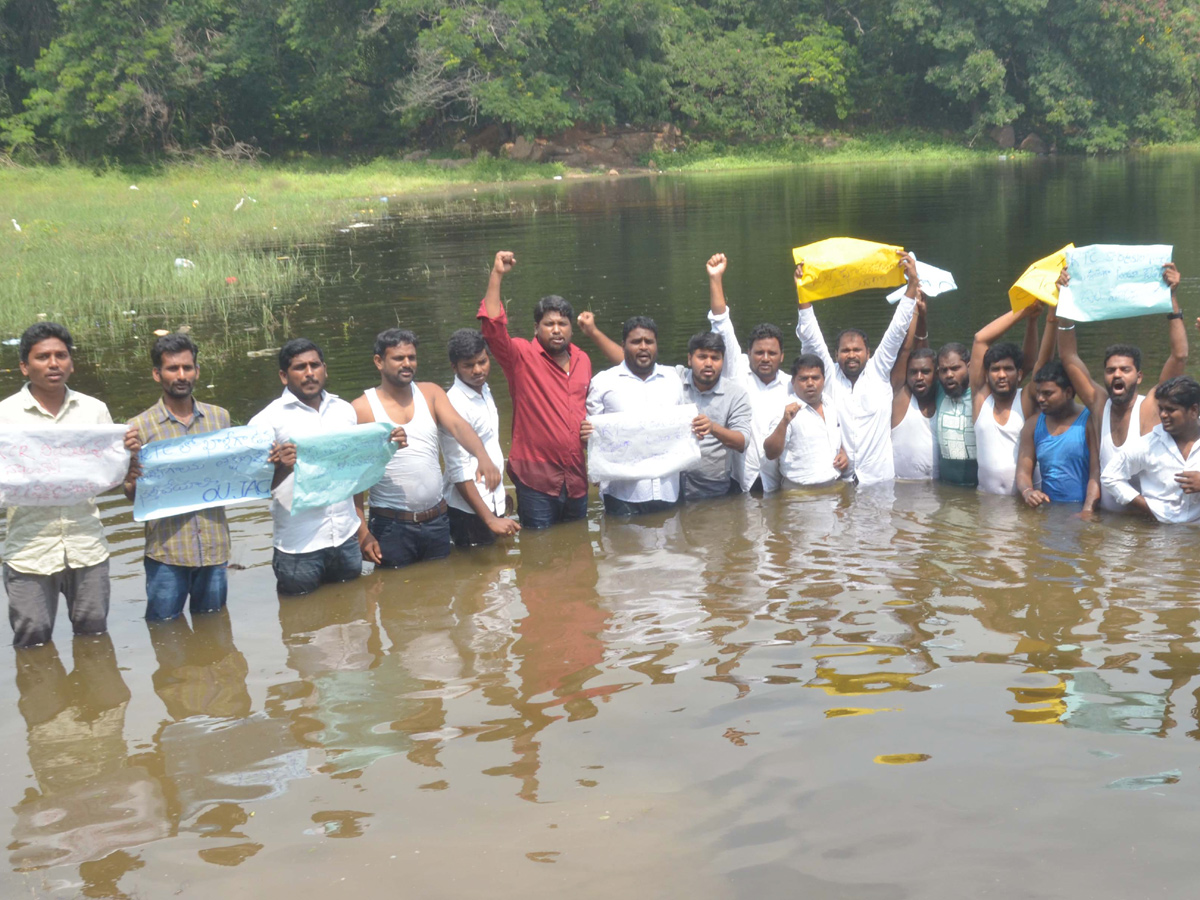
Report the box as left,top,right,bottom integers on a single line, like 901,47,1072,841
439,328,521,547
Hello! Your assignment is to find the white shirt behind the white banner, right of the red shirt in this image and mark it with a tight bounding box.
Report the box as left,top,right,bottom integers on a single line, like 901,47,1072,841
588,362,684,503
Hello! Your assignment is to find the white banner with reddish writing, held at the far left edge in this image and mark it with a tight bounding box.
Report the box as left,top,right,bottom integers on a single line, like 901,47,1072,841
0,425,130,506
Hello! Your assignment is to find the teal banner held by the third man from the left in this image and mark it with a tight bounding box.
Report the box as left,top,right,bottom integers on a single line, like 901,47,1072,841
285,422,398,512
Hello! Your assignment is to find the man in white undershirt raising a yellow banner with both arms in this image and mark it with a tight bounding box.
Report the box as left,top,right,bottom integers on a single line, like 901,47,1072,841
970,304,1056,494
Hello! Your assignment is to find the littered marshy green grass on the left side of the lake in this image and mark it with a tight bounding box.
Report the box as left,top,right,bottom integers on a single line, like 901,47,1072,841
0,154,560,338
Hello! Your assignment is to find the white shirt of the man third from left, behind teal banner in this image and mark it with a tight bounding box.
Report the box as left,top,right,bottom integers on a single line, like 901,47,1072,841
250,388,359,553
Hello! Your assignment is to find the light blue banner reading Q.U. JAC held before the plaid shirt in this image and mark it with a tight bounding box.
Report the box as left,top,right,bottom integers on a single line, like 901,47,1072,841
133,425,275,522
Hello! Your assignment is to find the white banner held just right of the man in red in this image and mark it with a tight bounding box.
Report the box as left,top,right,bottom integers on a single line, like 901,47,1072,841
588,403,700,481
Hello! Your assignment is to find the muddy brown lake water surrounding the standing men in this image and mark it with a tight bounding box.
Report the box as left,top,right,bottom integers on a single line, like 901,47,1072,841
0,156,1200,900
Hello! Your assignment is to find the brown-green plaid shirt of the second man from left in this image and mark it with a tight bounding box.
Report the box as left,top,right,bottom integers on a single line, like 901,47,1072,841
130,397,230,568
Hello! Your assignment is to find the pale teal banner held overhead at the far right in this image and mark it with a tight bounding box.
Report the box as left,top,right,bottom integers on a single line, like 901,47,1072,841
1058,244,1175,322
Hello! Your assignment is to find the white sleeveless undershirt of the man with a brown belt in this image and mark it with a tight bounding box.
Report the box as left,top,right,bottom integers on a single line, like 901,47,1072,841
365,384,442,512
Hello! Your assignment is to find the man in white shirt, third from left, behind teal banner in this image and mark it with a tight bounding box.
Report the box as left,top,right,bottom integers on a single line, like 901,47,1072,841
250,337,366,595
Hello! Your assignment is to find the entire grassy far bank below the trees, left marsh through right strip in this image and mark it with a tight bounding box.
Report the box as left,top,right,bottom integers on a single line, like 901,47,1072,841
0,132,1196,338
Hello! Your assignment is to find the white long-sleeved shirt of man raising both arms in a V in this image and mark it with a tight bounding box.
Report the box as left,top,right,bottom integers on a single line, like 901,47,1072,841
796,296,917,485
